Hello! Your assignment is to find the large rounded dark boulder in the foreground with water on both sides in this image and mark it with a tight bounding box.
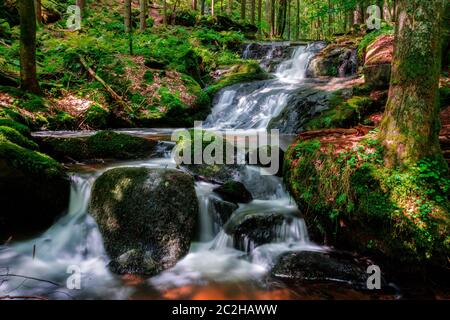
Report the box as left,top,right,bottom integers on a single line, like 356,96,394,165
90,168,198,275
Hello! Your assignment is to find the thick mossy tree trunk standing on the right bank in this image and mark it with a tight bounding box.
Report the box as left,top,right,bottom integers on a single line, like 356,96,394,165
381,0,446,167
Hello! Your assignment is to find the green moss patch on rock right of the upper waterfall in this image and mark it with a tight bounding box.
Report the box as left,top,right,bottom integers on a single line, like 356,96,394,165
305,92,374,130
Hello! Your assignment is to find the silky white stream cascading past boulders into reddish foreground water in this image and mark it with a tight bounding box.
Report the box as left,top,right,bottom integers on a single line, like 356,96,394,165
0,42,428,299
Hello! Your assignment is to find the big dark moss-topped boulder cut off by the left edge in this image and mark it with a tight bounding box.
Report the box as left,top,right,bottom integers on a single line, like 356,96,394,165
0,136,70,241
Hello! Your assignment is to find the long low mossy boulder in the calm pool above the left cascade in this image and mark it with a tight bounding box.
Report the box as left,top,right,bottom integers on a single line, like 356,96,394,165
38,131,157,161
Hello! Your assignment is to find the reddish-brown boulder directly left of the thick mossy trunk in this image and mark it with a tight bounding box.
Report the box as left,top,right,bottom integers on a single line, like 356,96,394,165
363,35,394,88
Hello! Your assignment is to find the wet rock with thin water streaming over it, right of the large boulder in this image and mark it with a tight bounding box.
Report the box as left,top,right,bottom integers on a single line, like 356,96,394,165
224,211,292,251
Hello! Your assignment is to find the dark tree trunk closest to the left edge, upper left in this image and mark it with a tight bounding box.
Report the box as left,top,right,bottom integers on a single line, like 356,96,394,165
18,0,41,94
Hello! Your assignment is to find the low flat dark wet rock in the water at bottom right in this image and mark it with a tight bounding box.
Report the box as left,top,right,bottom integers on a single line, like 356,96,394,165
271,251,368,287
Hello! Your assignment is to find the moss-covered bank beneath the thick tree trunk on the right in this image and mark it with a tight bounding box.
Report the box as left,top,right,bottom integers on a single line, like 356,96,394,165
284,133,450,264
